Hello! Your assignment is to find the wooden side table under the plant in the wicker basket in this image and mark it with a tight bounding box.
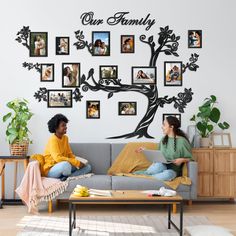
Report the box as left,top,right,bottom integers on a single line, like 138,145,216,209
0,156,30,208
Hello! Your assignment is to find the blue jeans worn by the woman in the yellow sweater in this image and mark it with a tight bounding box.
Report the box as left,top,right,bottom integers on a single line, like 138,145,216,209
48,161,92,179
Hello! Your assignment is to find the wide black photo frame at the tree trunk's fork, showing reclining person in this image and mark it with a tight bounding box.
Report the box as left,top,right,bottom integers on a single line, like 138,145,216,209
131,66,157,85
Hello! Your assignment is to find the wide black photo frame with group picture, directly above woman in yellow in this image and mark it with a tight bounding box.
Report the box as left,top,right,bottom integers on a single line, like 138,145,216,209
47,89,73,108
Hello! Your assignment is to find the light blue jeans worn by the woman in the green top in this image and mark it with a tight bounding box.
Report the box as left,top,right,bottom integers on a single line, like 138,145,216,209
134,162,177,181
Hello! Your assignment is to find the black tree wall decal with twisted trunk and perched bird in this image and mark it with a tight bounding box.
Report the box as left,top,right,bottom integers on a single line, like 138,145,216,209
74,26,199,139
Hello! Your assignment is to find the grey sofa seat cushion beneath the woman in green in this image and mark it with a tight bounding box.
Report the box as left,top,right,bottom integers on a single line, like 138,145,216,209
112,176,190,192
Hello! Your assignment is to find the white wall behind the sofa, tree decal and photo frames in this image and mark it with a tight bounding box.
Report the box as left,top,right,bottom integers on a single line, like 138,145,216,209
0,0,236,197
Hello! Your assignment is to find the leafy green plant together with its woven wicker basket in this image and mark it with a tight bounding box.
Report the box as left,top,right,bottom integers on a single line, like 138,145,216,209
3,99,33,156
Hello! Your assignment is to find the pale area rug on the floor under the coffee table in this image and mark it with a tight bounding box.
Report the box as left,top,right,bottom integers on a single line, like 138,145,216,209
17,215,211,236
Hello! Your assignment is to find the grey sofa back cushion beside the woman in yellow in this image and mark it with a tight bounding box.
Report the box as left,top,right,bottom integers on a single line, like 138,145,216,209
70,143,111,174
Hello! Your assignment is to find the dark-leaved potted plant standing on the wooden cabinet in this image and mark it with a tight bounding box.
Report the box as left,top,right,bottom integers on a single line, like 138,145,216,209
190,95,230,147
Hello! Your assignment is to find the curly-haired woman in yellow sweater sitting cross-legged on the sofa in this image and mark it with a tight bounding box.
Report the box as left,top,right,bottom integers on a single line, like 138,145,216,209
43,114,91,180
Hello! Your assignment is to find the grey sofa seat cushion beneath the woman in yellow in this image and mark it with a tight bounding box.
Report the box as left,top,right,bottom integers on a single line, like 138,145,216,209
57,175,111,199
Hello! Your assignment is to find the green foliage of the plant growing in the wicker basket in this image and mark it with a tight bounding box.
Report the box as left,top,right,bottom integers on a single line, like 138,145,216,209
3,99,33,144
